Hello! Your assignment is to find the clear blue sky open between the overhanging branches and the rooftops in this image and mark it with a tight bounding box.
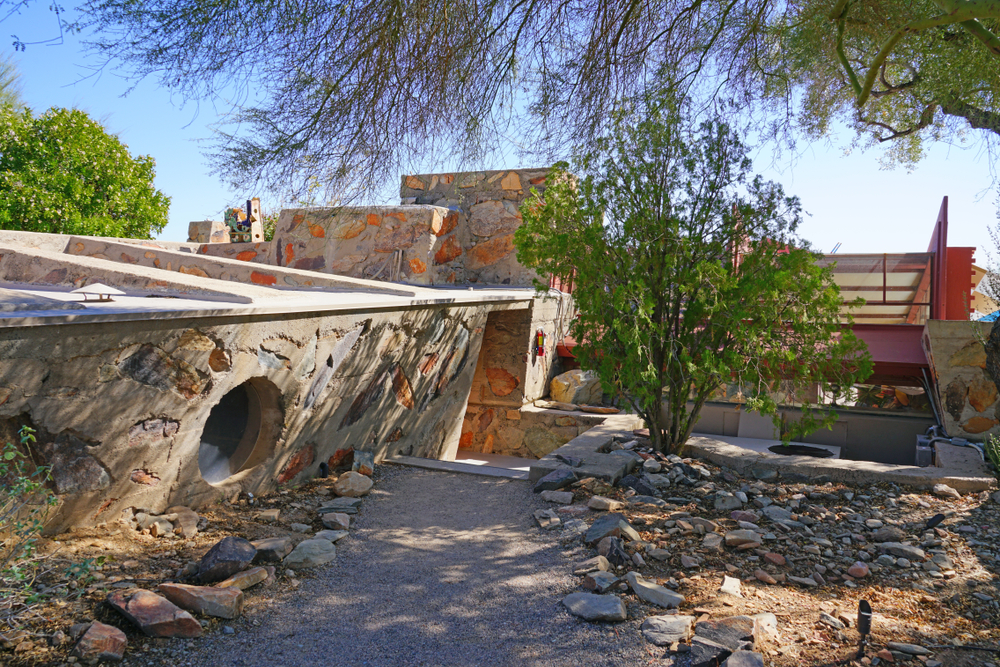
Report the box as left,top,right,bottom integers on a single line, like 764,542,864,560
0,4,997,265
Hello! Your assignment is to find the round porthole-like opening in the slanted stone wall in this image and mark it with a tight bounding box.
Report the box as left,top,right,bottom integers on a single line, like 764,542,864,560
198,378,284,484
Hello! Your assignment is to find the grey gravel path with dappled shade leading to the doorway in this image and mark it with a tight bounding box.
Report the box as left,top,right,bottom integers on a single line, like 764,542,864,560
144,465,656,667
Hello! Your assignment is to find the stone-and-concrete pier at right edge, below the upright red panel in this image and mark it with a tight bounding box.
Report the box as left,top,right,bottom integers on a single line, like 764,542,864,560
922,320,1000,441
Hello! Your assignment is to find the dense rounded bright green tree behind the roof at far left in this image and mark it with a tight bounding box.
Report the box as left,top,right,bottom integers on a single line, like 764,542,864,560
0,107,170,238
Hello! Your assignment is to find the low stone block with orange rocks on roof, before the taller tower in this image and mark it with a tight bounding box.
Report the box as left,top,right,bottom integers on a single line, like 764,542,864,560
270,206,450,285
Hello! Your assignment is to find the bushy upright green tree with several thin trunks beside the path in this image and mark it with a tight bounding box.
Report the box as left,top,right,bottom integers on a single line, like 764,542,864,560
515,98,871,450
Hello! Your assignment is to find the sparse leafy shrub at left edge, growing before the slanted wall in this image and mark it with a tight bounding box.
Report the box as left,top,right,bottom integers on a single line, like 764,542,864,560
0,426,58,597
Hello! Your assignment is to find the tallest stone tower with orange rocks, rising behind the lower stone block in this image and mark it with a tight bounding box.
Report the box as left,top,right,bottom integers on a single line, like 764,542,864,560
400,169,546,287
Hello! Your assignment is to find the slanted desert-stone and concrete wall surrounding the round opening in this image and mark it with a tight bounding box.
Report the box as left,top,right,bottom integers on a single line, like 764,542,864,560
0,304,523,530
